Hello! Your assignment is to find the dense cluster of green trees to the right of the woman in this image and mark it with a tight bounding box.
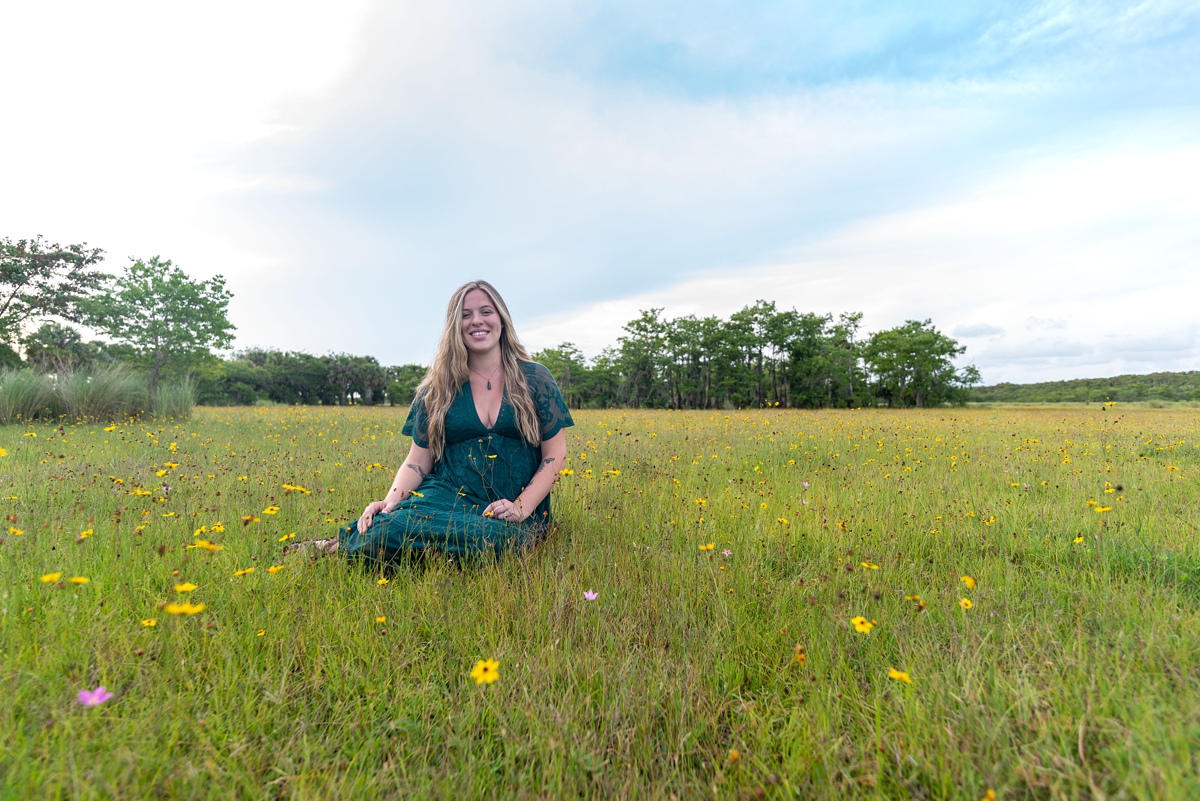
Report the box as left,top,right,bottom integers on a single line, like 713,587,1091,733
533,300,979,409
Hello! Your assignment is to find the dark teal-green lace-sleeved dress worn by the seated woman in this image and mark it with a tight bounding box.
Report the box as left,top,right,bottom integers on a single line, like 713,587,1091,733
338,362,575,561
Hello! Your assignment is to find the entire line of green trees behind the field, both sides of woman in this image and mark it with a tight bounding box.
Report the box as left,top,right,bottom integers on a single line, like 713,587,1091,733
7,237,979,409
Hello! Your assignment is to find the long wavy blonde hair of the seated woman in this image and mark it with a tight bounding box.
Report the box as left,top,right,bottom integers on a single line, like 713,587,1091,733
416,281,541,462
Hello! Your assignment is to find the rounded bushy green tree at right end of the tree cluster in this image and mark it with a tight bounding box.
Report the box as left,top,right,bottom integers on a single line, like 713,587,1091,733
863,320,979,409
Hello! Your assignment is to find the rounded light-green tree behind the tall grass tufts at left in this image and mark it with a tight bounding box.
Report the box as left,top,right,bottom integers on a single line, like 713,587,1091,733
85,255,234,395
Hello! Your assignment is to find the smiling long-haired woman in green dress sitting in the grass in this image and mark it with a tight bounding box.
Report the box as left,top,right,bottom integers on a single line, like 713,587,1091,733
288,281,575,561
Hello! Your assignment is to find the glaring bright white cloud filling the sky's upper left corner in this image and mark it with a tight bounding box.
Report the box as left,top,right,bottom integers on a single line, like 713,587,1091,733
0,0,367,297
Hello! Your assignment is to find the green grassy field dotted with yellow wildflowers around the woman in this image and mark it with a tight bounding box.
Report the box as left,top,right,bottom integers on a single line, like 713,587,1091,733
0,406,1200,800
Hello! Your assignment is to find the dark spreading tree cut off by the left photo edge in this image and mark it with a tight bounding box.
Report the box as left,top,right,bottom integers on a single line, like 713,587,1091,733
0,236,112,344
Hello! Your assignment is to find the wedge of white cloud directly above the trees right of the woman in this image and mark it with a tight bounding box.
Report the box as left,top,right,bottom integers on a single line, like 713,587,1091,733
524,135,1200,383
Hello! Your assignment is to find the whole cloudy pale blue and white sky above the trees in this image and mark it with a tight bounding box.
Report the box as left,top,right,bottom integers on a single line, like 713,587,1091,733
0,0,1200,384
